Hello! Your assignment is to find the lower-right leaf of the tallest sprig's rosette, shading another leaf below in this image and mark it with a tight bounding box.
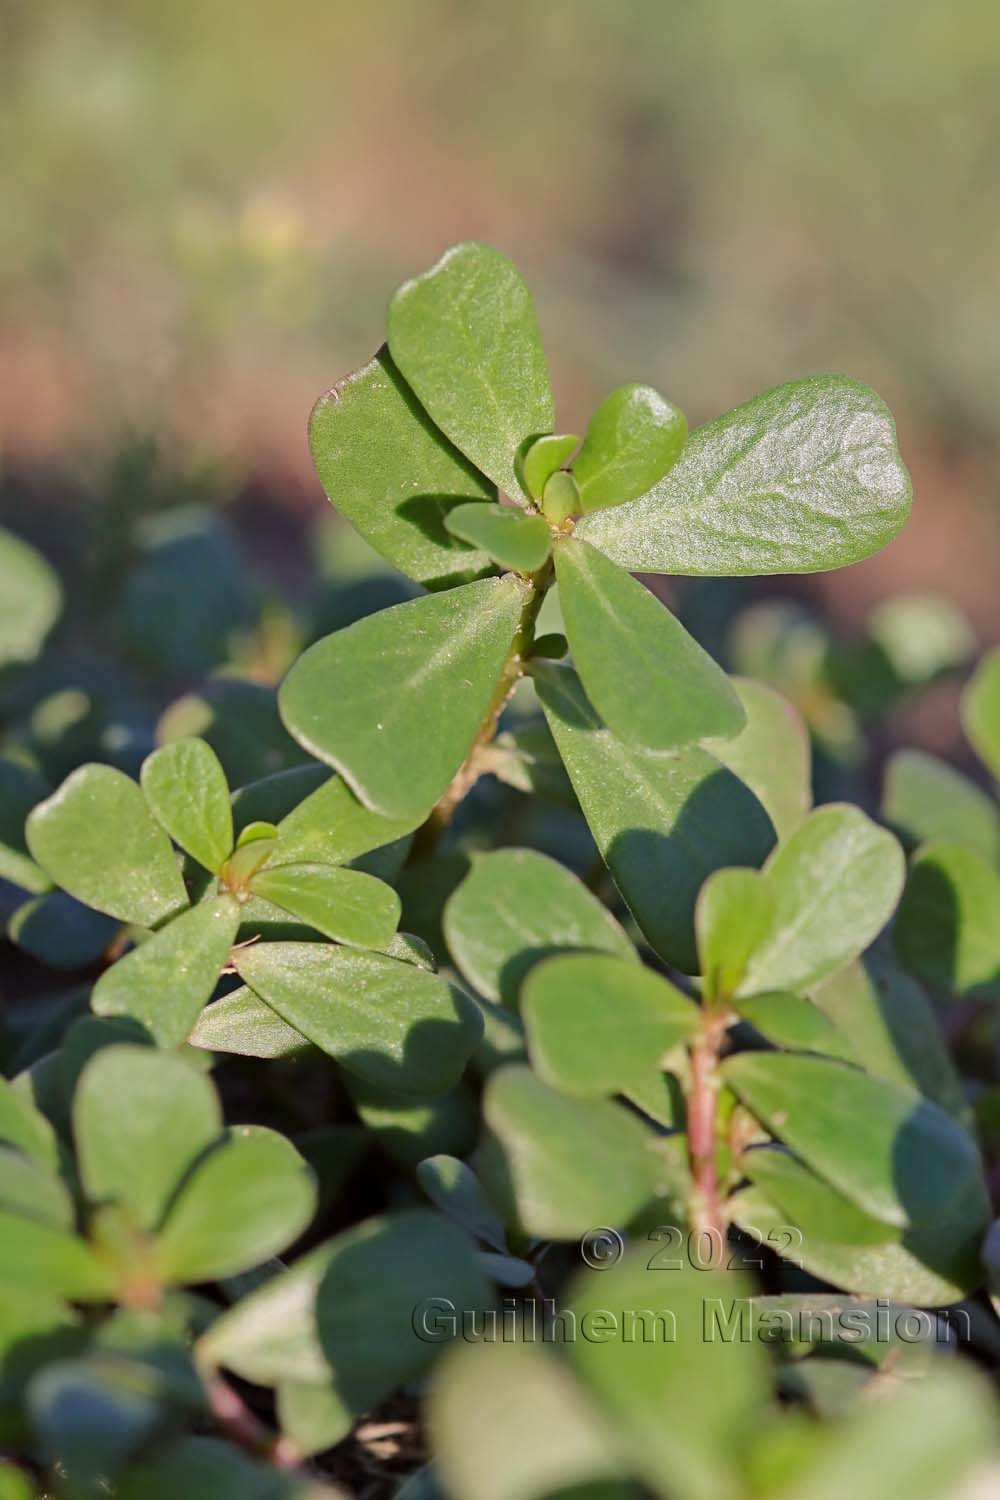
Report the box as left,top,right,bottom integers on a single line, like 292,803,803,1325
555,537,747,750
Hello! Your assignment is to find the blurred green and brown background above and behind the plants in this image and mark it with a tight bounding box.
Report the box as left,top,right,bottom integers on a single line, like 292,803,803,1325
0,0,1000,651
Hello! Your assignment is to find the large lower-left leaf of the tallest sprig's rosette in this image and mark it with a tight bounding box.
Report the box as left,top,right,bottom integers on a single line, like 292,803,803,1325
279,575,529,819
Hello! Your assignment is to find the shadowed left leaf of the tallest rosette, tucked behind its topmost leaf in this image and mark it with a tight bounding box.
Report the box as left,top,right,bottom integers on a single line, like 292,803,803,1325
309,348,496,588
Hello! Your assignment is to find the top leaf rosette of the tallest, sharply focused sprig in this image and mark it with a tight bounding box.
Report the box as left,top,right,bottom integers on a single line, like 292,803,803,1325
280,245,910,816
